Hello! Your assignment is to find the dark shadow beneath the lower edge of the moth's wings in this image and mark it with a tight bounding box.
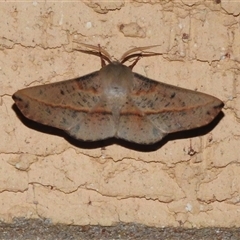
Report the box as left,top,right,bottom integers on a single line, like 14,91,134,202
12,104,224,152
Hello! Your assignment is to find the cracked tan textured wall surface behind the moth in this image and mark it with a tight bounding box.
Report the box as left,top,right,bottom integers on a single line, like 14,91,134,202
0,0,240,227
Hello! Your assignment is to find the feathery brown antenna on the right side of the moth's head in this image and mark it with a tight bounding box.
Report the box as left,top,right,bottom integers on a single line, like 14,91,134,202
120,45,161,63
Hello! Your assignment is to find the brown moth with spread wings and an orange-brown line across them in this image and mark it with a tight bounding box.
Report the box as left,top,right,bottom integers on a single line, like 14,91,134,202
13,44,224,144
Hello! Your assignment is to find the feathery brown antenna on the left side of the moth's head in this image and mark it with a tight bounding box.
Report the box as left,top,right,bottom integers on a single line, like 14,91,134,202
73,42,112,66
